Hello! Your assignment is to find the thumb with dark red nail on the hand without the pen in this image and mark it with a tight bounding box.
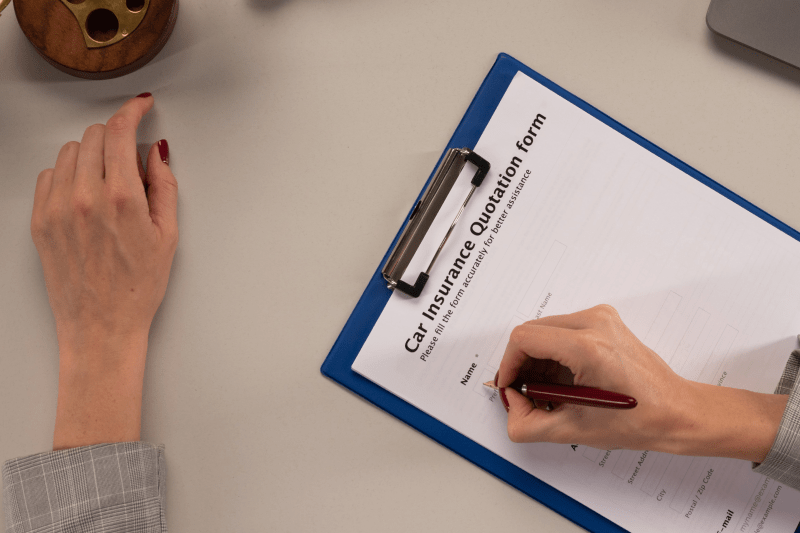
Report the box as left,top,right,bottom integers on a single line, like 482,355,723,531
145,139,178,229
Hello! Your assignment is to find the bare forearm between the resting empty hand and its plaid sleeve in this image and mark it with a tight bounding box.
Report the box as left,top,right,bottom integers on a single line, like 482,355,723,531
53,335,147,450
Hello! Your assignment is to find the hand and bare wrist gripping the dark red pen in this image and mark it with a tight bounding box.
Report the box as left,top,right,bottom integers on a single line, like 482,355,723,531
497,305,787,462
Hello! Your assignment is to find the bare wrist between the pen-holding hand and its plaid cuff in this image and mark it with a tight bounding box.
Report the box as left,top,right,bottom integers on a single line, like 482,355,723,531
659,382,788,463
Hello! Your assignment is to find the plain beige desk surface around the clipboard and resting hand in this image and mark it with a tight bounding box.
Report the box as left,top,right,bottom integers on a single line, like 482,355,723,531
0,0,800,532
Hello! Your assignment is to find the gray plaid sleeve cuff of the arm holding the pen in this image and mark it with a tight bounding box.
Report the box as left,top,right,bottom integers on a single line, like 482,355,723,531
753,350,800,490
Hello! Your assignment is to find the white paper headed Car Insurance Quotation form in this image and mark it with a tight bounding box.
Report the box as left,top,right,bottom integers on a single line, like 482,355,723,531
353,73,800,533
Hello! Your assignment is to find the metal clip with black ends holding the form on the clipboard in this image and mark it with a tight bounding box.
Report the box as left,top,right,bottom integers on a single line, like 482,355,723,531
381,148,490,298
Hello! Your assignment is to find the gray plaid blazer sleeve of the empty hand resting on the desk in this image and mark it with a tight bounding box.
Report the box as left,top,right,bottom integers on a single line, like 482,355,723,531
3,442,167,533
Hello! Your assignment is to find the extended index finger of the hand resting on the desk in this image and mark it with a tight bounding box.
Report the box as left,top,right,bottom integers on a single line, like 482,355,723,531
103,93,153,188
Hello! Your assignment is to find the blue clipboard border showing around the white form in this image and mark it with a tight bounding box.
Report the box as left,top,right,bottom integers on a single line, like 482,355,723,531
321,54,800,533
